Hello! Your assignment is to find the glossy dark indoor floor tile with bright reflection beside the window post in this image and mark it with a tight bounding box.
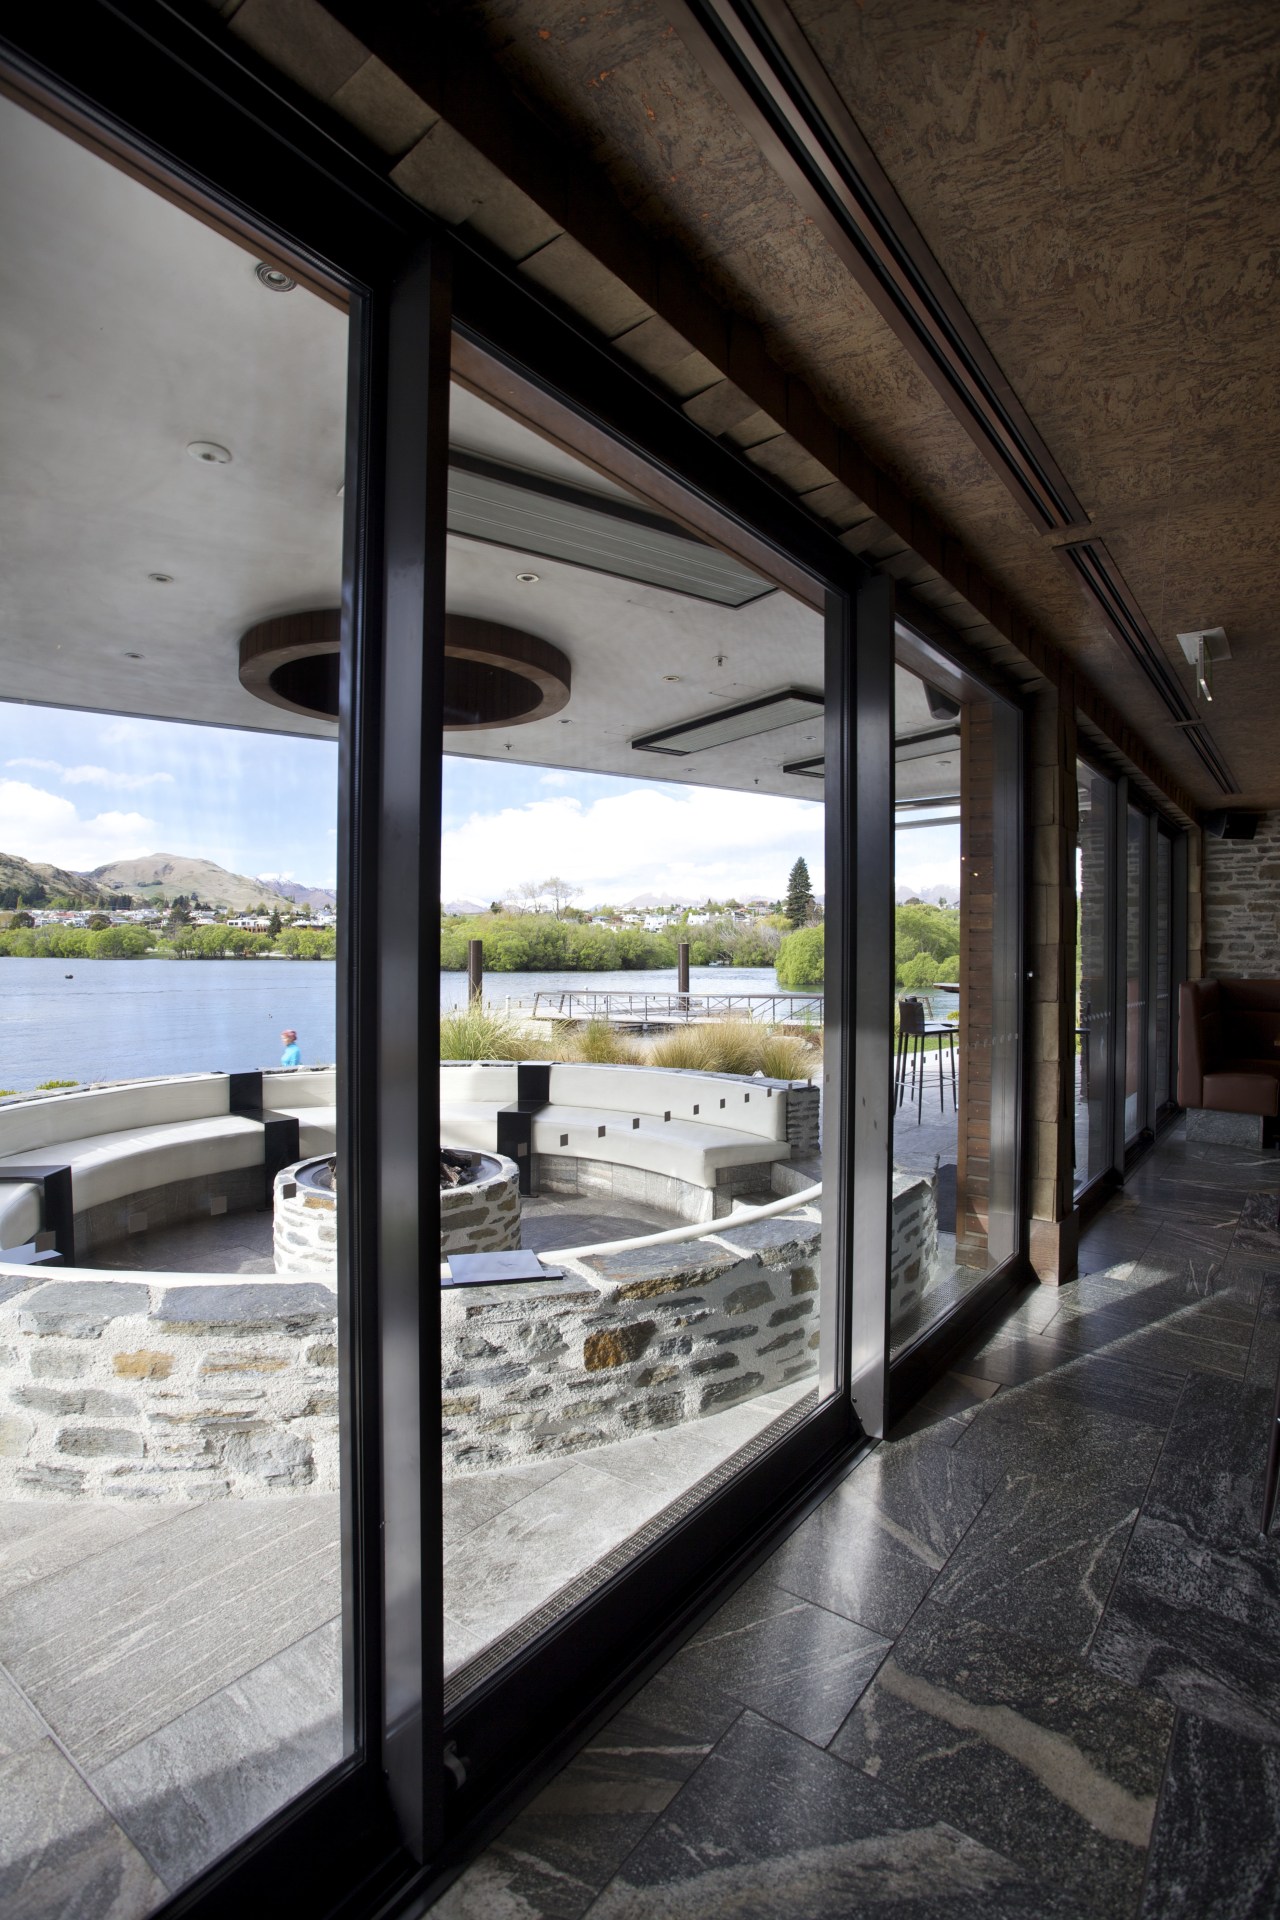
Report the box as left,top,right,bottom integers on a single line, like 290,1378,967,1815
766,1432,986,1634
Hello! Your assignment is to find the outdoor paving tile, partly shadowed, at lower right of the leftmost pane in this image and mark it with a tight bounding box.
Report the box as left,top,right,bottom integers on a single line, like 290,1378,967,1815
90,1620,342,1887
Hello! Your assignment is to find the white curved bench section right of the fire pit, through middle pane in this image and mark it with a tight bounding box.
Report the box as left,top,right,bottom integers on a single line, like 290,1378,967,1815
439,1060,793,1219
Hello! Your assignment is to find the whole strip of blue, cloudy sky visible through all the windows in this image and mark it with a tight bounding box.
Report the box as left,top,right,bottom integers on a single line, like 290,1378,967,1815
0,701,958,906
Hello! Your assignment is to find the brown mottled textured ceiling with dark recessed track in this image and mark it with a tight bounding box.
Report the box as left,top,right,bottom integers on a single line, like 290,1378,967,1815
450,0,1280,804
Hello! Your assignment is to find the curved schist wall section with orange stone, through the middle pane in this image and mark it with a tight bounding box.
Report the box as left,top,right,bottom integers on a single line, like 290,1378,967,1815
441,1208,821,1475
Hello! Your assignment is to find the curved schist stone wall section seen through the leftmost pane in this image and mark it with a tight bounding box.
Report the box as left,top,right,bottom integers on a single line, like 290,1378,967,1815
0,1267,338,1500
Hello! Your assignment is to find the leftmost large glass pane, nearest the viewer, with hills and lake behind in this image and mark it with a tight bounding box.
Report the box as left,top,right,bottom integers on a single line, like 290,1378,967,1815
0,98,349,1914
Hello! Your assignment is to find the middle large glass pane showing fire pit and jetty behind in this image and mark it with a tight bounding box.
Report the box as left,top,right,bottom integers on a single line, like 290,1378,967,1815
439,367,839,1701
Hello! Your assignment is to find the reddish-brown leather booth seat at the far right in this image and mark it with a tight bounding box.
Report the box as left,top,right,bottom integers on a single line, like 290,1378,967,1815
1178,979,1280,1119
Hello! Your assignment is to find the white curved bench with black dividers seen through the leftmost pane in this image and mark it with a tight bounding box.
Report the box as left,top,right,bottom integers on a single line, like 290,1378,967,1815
0,1068,336,1248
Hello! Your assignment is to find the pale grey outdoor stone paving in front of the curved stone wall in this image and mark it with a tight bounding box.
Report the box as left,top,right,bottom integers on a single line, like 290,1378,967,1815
0,1382,809,1920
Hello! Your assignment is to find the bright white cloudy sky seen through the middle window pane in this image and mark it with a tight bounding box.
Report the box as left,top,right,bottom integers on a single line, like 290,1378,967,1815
441,787,823,904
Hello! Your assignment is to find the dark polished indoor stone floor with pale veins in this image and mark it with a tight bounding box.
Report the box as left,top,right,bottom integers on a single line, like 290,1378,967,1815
434,1135,1280,1920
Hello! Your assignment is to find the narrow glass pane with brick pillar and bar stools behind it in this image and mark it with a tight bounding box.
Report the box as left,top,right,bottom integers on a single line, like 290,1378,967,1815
890,634,1021,1352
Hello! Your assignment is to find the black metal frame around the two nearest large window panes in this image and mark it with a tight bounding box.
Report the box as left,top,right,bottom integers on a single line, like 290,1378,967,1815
0,0,909,1914
